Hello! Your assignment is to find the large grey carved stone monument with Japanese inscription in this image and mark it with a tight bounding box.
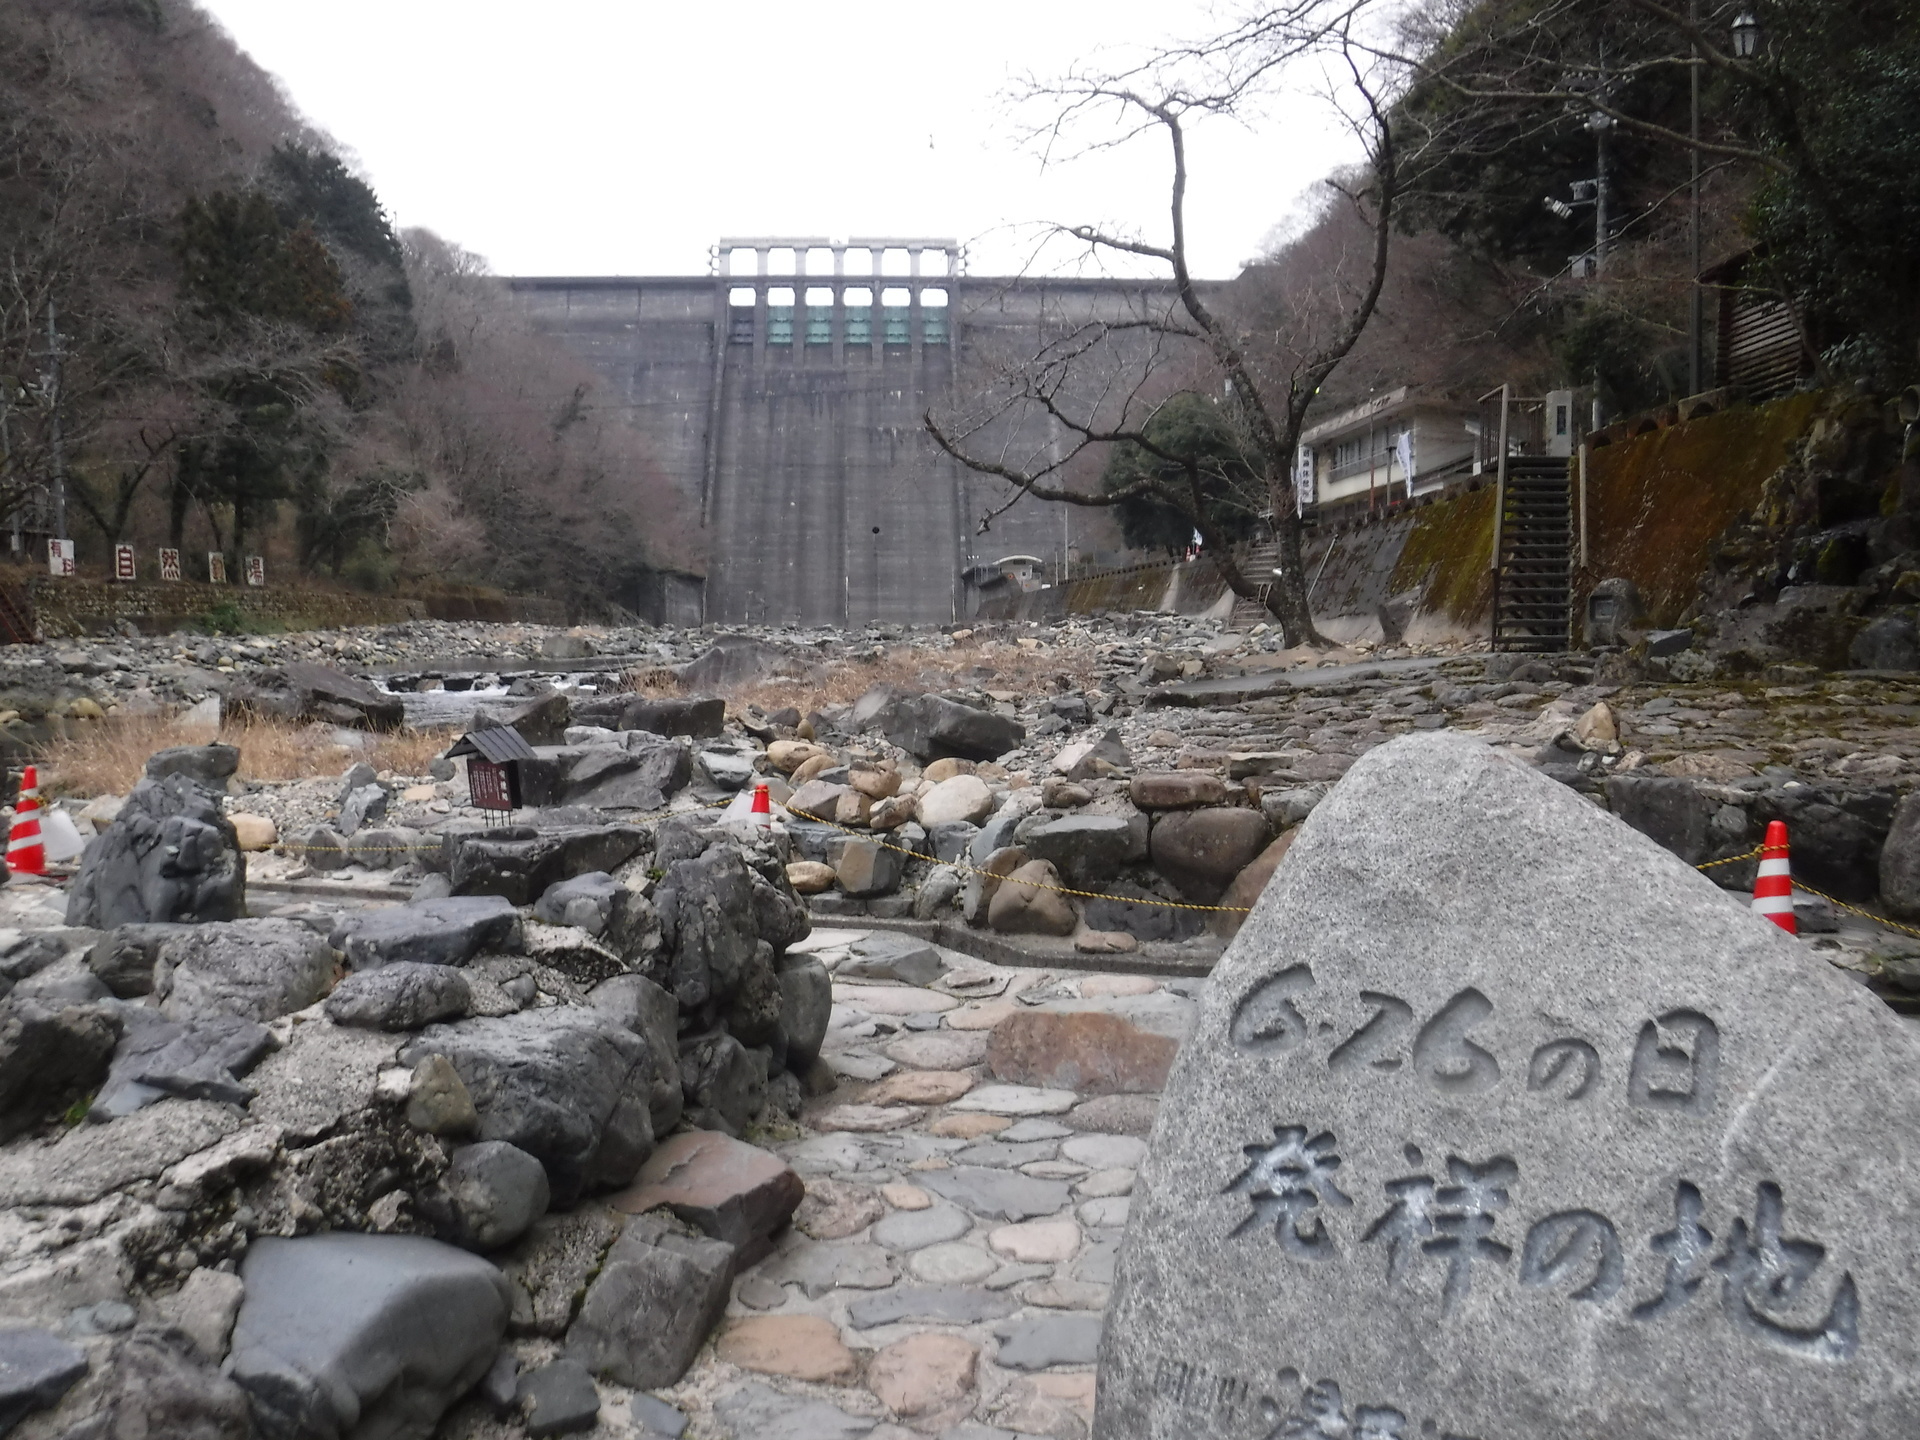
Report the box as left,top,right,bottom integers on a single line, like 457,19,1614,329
1094,733,1920,1440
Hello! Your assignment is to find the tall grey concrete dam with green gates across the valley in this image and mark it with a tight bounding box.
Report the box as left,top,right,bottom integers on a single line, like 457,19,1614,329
507,238,1177,624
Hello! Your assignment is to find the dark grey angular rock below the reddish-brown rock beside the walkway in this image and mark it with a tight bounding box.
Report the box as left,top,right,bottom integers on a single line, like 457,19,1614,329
566,1215,735,1390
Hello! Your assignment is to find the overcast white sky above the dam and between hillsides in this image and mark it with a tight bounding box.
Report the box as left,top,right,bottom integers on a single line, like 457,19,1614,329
200,0,1354,276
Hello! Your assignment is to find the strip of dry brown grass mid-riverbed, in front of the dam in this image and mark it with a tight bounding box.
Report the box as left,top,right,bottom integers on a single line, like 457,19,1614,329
626,639,1094,714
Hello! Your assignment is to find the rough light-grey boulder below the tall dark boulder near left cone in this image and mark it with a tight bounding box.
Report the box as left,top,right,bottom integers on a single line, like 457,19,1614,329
154,920,334,1023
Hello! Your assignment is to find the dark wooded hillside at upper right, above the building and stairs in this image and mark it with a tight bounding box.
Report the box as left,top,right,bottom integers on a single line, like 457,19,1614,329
1236,0,1920,415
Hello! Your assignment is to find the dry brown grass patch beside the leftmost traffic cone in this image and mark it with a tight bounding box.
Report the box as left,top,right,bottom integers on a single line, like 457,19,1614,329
35,714,455,795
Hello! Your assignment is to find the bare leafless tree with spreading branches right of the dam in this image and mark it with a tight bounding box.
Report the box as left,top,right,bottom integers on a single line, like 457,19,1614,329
925,0,1398,645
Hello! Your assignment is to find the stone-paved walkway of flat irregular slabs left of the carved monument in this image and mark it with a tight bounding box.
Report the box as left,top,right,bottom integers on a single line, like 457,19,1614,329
656,929,1200,1440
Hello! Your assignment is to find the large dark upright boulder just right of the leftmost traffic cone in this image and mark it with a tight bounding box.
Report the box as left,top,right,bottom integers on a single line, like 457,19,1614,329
67,774,246,929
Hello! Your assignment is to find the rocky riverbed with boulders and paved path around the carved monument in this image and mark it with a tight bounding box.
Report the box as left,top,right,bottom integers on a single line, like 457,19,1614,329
0,616,1920,1440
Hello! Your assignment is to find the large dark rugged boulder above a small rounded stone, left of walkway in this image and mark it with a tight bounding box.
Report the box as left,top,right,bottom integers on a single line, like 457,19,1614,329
399,1006,653,1208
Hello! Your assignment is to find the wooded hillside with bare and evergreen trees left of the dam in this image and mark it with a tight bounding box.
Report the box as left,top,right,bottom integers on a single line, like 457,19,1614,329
0,0,699,612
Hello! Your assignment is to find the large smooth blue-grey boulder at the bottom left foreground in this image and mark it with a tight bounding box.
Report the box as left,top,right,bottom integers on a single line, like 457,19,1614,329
228,1233,513,1440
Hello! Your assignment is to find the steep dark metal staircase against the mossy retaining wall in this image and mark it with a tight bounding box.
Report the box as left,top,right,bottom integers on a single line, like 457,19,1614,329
1494,455,1572,653
